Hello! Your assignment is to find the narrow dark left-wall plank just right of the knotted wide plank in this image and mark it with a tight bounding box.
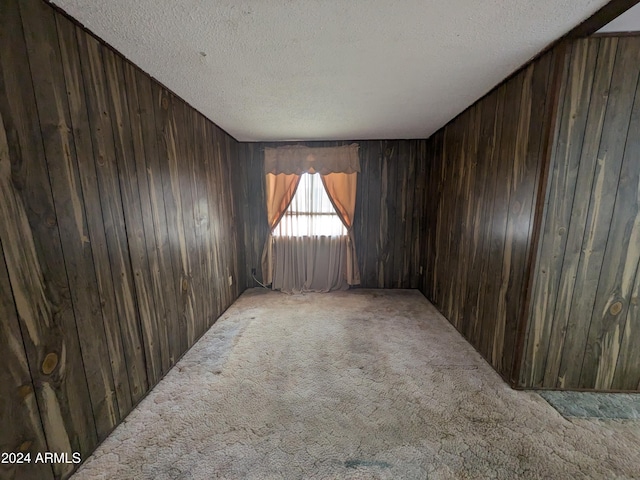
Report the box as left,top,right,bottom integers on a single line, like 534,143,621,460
21,2,120,439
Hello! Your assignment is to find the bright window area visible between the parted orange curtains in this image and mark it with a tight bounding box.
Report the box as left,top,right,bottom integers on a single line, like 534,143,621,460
273,173,347,237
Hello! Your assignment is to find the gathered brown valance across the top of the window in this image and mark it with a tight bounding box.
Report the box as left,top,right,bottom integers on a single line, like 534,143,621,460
264,143,360,175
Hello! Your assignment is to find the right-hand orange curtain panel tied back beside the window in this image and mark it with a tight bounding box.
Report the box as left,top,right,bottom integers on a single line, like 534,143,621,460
321,173,360,285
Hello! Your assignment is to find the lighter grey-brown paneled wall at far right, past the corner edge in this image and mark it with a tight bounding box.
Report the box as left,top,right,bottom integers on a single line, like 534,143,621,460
520,37,640,391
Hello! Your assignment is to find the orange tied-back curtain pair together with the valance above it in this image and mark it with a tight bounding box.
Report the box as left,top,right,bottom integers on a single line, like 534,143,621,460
262,143,360,288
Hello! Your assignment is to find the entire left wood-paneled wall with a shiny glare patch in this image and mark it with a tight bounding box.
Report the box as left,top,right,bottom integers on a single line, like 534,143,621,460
0,0,246,479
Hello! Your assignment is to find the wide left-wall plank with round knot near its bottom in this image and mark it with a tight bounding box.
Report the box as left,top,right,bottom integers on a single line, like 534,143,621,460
0,1,97,470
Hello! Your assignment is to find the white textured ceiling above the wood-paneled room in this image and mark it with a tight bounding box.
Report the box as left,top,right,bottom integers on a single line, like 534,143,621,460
53,0,608,141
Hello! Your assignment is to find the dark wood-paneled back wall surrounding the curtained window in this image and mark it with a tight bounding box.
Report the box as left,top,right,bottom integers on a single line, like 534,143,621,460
240,140,426,288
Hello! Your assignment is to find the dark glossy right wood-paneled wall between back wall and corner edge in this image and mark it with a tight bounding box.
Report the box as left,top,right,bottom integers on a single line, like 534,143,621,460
422,50,560,379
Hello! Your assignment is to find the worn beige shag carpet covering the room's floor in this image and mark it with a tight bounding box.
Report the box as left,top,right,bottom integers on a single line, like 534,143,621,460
73,289,640,480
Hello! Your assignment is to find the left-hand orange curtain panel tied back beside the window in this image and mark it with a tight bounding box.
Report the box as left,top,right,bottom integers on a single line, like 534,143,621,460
262,173,300,285
